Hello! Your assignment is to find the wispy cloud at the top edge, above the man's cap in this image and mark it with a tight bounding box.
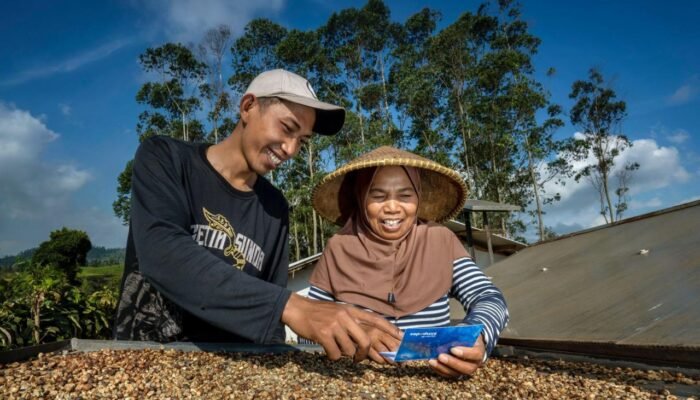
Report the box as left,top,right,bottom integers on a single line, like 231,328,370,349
146,0,284,43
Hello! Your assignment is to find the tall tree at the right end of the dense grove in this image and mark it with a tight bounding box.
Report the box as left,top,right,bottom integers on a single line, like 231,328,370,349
482,0,570,240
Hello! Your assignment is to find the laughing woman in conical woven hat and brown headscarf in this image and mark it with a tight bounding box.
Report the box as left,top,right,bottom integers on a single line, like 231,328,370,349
309,147,508,377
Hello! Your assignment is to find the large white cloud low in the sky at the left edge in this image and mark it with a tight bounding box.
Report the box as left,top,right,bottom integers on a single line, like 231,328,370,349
0,102,126,255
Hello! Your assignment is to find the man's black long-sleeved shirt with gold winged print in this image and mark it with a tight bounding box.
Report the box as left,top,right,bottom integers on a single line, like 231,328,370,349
115,137,290,343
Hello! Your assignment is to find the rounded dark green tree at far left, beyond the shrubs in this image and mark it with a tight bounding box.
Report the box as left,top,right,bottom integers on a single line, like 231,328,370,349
32,227,92,284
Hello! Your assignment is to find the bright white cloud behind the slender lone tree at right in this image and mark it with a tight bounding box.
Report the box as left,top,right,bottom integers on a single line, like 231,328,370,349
544,135,691,233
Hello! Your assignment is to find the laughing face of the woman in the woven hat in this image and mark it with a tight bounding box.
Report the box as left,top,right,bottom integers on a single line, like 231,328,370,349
365,166,418,240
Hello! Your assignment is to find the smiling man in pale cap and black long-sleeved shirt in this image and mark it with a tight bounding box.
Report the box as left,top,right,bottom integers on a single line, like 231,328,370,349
114,69,400,360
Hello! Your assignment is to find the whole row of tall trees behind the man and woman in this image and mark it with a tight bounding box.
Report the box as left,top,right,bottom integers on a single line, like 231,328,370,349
114,0,639,259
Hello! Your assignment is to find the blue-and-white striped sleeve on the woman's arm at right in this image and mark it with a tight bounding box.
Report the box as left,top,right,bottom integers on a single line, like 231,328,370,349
451,257,508,356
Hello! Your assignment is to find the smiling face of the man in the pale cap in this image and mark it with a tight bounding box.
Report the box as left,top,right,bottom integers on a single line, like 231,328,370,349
242,99,316,175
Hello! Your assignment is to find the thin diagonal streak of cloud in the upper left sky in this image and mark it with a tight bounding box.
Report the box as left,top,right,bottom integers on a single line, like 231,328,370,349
0,39,131,86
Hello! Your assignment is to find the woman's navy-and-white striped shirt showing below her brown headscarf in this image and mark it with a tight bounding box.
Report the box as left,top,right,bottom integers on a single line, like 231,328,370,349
300,257,508,355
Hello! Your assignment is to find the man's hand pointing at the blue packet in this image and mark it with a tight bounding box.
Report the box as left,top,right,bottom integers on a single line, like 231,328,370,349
282,293,401,361
